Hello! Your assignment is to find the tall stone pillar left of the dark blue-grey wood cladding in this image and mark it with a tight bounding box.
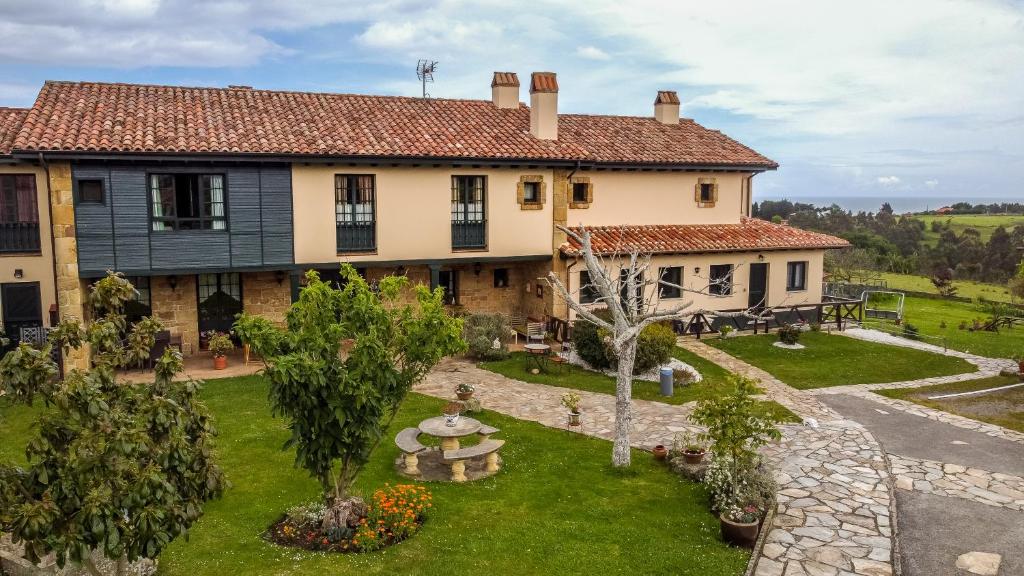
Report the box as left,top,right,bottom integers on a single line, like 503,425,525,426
49,162,89,369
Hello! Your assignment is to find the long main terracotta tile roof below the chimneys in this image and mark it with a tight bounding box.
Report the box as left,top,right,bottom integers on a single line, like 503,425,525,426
13,77,776,168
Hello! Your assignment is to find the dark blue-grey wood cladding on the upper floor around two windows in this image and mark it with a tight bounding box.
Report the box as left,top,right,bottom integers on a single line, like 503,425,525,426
72,163,294,277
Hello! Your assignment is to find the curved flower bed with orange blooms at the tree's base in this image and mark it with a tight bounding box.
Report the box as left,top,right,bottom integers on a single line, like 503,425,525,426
267,484,433,552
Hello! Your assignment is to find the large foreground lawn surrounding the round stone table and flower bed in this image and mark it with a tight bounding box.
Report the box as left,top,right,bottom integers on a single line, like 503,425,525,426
0,377,749,576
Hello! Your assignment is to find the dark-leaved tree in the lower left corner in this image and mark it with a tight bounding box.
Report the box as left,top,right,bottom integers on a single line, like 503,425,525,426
0,274,226,575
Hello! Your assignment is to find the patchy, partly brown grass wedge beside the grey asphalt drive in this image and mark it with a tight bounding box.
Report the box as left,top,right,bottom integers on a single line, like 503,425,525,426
876,376,1024,433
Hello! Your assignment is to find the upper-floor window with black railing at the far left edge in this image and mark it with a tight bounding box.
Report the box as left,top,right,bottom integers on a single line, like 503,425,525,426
0,174,40,252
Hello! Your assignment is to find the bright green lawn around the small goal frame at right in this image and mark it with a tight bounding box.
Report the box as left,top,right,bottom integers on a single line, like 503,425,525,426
867,296,1024,358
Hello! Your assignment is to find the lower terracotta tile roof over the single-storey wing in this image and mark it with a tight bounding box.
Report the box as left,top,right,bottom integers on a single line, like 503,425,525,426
561,218,850,256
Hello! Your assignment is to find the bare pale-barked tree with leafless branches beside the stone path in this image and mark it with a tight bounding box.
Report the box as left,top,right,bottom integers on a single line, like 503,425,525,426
547,227,771,466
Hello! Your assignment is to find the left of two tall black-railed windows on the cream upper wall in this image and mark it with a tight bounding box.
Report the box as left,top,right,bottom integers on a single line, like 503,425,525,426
334,174,377,252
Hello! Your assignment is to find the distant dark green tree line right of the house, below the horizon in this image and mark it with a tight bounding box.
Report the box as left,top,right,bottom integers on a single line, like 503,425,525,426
753,200,1024,283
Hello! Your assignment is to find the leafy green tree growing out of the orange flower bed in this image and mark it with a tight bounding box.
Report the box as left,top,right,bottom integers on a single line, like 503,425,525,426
236,264,466,528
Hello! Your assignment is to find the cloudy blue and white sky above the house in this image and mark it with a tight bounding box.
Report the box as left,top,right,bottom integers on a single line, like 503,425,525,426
0,0,1024,200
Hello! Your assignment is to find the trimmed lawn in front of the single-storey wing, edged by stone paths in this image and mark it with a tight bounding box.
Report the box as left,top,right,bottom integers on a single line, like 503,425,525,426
707,332,977,389
